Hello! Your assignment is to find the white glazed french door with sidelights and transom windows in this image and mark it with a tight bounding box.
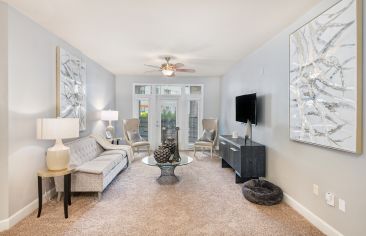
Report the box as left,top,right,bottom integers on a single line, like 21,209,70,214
133,84,203,149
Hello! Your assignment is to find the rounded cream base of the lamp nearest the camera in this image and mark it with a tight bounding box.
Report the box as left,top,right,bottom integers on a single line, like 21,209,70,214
46,141,70,171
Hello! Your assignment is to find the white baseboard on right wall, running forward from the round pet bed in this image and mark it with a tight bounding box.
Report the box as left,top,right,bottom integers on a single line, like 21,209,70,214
283,193,343,236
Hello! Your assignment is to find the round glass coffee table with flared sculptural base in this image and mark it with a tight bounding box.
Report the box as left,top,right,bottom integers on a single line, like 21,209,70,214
142,154,193,184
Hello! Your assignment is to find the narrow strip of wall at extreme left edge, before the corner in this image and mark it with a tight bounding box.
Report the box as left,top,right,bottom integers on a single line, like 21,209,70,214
0,2,9,221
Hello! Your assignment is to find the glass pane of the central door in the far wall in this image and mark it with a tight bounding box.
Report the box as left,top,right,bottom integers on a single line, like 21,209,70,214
160,102,177,143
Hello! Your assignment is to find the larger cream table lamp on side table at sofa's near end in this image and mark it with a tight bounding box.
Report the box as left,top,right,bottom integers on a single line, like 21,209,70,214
37,118,79,171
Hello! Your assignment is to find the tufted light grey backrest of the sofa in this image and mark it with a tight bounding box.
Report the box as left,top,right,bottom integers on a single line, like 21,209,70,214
65,137,104,167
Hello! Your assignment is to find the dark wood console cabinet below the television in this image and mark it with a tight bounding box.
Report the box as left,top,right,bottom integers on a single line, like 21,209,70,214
219,135,266,183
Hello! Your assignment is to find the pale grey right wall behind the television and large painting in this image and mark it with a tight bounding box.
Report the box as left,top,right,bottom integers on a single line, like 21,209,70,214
220,0,366,236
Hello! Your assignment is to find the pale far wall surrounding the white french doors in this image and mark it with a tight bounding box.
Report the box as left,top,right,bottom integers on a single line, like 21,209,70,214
115,75,220,137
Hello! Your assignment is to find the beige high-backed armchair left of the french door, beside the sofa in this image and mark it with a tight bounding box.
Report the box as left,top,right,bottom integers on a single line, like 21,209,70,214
123,118,150,155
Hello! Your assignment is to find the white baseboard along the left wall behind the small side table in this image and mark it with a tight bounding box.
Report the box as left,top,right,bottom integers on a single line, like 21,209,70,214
0,188,56,232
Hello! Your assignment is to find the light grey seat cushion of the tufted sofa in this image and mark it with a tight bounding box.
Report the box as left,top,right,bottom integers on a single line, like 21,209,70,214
76,154,123,176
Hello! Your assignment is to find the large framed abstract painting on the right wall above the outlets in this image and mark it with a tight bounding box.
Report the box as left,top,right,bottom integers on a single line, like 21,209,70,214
289,0,362,153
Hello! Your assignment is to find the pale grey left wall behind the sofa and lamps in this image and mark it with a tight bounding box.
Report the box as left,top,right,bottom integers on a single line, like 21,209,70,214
4,7,115,215
